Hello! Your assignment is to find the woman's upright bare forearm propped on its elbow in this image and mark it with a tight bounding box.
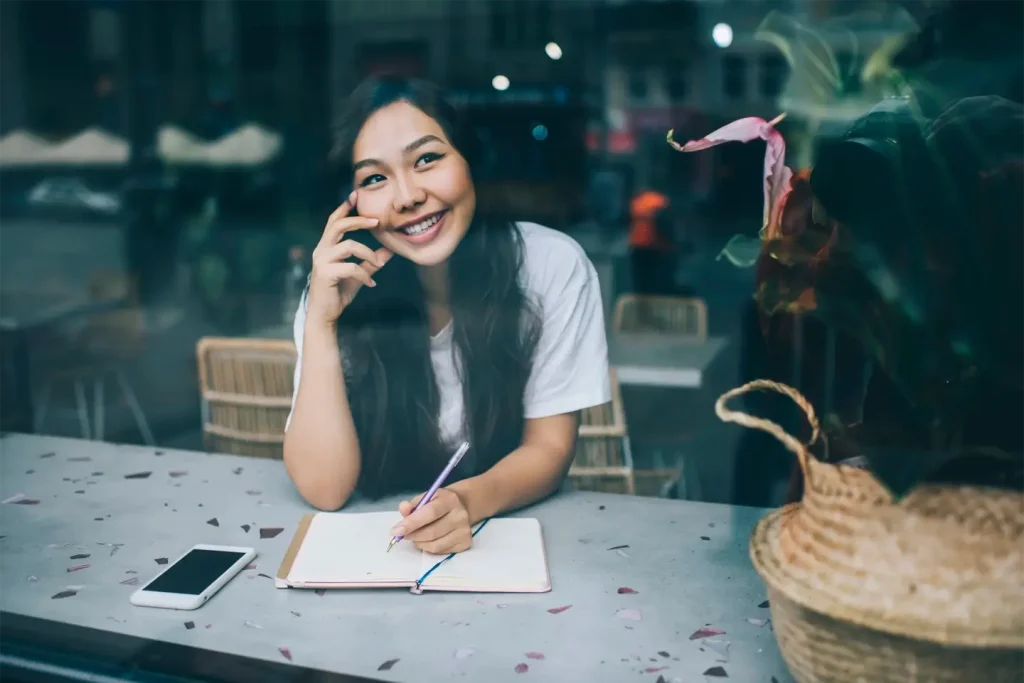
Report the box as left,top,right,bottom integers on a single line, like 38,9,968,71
285,323,360,510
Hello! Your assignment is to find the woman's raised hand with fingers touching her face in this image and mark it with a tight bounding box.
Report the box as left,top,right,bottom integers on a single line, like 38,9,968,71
306,190,391,325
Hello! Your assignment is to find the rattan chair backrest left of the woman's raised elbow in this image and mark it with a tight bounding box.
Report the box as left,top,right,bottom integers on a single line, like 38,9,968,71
196,337,297,458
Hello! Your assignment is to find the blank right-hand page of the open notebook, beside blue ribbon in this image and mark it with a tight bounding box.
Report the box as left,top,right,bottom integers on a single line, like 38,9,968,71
423,517,551,592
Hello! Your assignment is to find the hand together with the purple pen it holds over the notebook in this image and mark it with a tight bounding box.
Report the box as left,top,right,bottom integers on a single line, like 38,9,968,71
387,442,472,554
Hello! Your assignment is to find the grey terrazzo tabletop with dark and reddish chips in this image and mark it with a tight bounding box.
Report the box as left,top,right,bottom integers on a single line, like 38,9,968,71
0,434,792,683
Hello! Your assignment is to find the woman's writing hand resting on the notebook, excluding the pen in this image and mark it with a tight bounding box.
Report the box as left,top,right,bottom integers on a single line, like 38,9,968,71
392,488,473,555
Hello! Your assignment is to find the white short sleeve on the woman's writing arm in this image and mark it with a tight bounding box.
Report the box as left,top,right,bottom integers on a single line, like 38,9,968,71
523,243,611,419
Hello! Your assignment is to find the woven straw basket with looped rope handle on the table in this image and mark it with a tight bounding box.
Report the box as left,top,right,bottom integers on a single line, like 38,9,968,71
715,380,1024,683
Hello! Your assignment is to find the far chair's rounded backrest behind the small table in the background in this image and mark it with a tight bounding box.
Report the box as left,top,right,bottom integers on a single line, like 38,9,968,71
611,294,708,340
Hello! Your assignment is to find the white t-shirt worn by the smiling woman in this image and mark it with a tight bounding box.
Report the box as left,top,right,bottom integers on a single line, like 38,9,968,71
285,222,611,444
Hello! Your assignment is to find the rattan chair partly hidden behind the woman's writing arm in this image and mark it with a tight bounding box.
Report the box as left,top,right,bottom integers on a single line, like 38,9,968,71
566,369,636,496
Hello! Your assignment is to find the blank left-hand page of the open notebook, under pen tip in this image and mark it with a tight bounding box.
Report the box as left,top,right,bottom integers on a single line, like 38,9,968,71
288,512,422,584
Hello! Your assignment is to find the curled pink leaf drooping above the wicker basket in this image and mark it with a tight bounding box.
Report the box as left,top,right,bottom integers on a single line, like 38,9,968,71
669,114,793,238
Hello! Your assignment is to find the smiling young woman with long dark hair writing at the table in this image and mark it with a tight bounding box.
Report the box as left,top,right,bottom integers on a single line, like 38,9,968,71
285,79,610,553
